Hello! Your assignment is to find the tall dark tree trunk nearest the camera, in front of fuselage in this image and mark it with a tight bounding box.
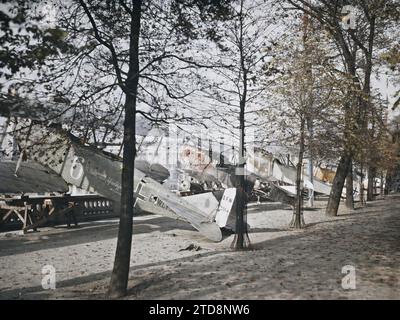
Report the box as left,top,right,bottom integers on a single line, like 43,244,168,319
108,0,141,298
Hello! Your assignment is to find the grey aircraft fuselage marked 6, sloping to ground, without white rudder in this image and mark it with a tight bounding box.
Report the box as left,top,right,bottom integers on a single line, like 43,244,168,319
10,125,222,241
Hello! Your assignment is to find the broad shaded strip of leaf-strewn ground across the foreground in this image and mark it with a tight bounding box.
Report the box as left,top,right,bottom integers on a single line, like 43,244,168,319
0,197,400,299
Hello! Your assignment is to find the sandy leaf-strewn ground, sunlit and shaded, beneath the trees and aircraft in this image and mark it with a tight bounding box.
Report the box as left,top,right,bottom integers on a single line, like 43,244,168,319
0,195,400,299
